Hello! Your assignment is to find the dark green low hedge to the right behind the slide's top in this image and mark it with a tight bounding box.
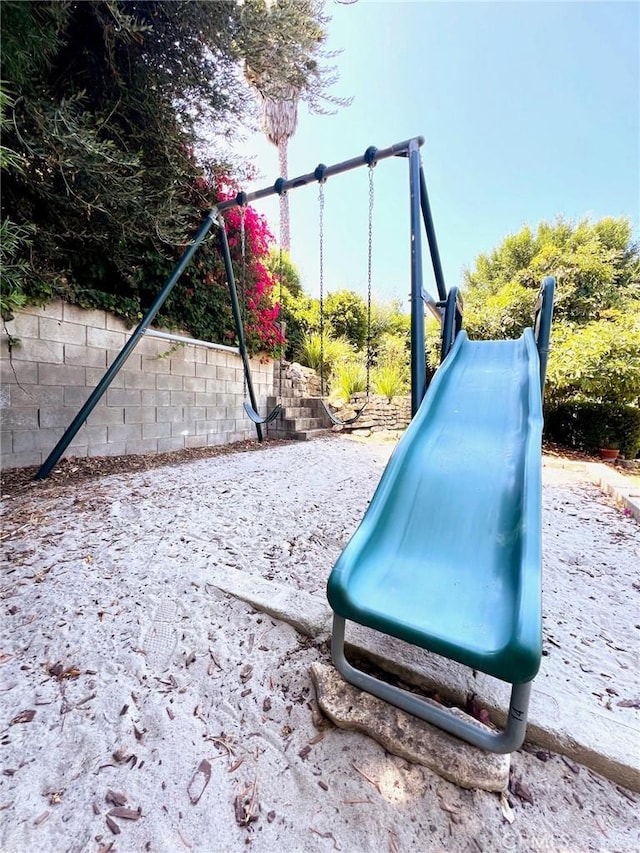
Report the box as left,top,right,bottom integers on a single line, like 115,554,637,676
545,401,640,459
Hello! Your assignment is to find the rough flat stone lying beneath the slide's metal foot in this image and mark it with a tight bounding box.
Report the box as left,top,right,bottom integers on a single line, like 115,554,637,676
310,663,511,791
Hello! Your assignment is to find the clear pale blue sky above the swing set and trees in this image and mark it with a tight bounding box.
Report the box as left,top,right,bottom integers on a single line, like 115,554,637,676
236,0,640,306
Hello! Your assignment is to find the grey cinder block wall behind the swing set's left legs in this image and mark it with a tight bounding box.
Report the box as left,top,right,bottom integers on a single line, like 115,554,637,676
0,302,273,468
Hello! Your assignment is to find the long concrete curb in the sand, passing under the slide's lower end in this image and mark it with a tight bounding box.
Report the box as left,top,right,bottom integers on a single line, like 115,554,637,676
221,580,640,792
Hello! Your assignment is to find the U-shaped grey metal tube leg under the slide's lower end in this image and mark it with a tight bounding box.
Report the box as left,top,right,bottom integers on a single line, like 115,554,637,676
331,613,531,753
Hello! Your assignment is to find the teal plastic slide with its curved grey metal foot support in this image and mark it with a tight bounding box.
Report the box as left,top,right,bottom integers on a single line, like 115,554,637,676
328,329,542,752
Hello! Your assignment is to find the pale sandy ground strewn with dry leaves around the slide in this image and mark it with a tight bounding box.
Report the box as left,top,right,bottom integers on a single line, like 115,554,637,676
0,437,640,853
